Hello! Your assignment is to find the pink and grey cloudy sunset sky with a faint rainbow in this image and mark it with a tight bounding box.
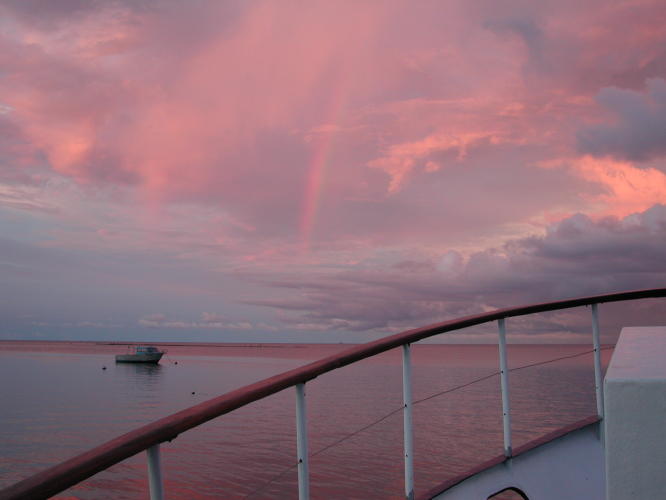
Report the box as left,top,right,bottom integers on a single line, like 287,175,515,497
0,0,666,342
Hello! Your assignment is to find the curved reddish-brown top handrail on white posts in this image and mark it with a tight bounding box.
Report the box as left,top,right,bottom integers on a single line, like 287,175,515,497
0,288,666,500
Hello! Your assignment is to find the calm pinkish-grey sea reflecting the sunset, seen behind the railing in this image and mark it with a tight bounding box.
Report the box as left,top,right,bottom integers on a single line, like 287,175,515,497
0,342,610,499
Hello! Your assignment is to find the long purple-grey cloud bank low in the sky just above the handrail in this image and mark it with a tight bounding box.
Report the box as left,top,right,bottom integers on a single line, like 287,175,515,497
243,205,666,331
